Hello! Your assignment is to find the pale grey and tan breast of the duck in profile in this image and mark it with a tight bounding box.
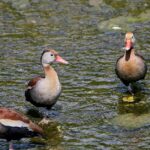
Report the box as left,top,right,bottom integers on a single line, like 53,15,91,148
31,68,61,105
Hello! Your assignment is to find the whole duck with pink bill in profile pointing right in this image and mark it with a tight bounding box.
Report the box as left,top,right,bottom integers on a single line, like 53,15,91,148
25,49,68,108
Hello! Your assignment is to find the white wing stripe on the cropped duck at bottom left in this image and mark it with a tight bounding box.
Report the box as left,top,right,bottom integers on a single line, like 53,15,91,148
0,119,32,131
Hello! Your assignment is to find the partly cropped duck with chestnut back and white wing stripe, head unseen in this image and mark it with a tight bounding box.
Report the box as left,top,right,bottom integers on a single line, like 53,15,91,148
0,107,43,150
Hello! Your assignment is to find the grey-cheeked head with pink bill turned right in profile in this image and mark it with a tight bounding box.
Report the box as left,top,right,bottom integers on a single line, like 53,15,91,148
41,49,68,66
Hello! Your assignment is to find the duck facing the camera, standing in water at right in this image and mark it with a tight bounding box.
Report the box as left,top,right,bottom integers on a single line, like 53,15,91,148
115,32,147,94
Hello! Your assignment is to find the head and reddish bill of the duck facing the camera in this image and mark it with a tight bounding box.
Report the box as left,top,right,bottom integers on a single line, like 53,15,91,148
124,32,135,51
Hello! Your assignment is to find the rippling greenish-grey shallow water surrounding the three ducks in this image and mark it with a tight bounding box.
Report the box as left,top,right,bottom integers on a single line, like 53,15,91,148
0,0,150,150
